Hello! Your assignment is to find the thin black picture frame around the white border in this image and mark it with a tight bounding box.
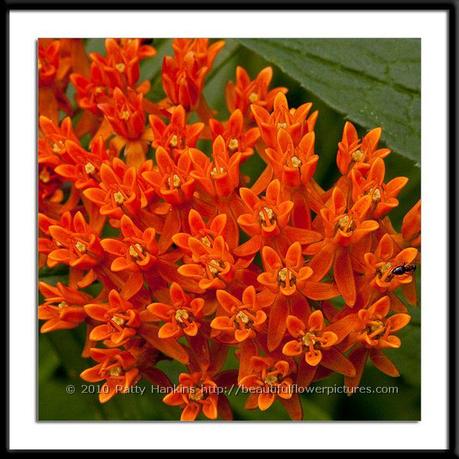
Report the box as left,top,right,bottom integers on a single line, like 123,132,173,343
1,0,459,457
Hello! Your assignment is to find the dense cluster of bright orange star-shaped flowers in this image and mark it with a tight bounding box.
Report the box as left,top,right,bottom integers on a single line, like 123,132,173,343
38,39,420,420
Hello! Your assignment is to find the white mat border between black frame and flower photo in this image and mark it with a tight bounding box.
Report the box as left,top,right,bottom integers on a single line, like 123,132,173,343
9,11,447,449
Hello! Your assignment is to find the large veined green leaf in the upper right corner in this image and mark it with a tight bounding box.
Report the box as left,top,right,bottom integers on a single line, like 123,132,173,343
240,39,421,163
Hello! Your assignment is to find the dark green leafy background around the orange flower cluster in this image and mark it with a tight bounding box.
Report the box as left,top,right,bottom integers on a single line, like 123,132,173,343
37,39,421,421
